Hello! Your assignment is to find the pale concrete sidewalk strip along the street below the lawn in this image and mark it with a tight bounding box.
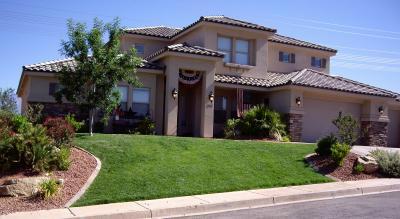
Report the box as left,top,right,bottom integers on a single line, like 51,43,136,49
0,178,400,219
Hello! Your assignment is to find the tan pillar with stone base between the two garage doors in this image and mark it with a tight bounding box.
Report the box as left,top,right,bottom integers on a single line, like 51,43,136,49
361,101,389,147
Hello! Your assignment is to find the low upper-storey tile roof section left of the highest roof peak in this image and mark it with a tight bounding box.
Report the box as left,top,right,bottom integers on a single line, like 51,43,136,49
124,26,182,38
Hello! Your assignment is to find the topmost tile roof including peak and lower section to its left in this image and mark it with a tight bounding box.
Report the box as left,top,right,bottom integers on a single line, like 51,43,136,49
124,16,276,39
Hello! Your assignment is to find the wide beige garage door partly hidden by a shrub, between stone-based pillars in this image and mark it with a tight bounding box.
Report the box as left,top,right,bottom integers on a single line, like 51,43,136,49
302,97,361,142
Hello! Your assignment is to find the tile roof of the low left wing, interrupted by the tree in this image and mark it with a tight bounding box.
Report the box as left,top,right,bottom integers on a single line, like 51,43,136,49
22,58,163,73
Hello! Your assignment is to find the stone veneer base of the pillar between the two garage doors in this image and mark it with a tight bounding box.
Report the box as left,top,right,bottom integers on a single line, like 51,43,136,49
361,121,388,147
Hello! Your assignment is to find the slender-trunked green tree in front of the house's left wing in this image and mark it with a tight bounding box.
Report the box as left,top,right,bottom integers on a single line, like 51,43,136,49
55,18,142,135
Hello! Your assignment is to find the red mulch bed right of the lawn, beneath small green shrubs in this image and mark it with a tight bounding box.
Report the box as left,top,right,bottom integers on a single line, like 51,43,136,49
307,153,382,181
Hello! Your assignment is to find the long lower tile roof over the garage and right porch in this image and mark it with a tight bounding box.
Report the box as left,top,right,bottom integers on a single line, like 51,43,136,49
215,69,398,98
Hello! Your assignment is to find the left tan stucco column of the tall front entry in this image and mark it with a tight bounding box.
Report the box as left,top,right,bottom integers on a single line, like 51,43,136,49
164,59,179,135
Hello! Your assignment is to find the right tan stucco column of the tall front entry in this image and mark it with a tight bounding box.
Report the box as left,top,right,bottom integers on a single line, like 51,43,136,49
200,65,215,138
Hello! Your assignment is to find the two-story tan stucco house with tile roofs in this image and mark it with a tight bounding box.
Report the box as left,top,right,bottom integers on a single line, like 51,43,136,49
18,16,400,147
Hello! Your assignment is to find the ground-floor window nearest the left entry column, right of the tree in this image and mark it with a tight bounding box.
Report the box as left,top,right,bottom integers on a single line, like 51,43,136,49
132,88,150,117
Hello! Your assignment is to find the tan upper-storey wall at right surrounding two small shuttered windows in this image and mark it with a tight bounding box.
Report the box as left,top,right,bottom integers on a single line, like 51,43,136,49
268,42,333,73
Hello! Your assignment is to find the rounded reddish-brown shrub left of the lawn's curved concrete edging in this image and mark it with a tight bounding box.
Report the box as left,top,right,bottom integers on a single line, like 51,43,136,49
43,117,75,148
